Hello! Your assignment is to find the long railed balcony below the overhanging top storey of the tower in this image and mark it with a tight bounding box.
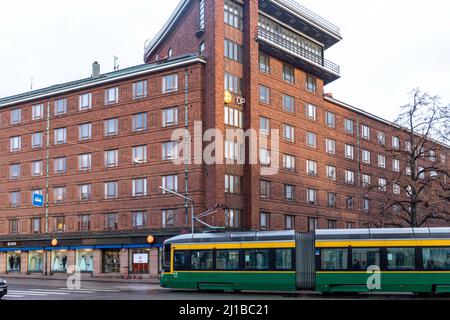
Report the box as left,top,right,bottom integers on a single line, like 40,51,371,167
256,27,340,84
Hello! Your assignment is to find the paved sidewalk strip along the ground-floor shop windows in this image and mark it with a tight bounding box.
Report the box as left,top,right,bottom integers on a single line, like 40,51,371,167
0,274,159,284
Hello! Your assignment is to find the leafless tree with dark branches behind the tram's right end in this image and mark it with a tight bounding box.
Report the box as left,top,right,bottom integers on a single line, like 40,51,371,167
367,89,450,227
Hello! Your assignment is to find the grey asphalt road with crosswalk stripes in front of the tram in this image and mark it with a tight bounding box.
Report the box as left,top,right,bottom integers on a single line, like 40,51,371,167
3,278,442,301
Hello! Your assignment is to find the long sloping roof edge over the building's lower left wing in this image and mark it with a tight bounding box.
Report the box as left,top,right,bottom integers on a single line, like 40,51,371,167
0,55,206,108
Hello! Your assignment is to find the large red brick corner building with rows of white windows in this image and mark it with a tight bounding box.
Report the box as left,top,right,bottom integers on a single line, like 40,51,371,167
0,0,448,276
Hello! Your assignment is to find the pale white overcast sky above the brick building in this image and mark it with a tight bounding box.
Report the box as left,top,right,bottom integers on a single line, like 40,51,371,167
0,0,450,120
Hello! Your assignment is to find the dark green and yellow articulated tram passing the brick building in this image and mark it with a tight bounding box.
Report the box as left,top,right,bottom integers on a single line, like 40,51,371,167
161,228,450,293
